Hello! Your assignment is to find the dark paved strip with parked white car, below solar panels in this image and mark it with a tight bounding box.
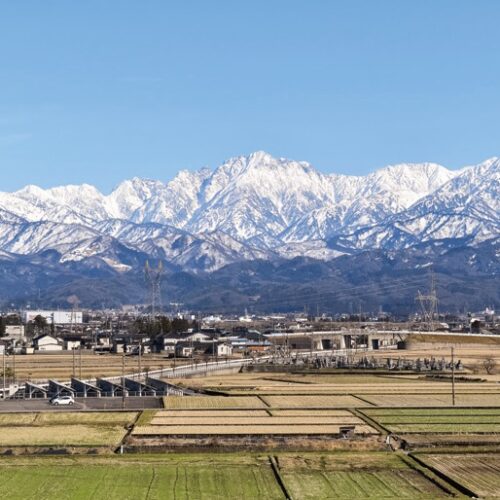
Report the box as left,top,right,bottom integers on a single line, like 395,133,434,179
0,397,163,413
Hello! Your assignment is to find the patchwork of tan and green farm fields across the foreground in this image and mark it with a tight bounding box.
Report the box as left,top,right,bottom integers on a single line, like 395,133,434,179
0,364,500,500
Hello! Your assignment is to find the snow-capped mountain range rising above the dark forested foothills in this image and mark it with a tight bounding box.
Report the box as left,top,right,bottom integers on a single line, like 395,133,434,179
0,152,500,272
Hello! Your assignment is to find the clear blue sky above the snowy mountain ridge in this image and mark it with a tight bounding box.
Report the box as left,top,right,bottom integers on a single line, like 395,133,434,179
0,0,500,191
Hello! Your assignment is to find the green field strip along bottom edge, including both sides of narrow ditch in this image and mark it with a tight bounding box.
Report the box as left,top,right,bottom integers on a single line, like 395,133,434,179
0,452,462,500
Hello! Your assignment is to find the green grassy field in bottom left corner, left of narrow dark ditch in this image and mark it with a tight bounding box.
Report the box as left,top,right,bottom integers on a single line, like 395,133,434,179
0,455,283,500
